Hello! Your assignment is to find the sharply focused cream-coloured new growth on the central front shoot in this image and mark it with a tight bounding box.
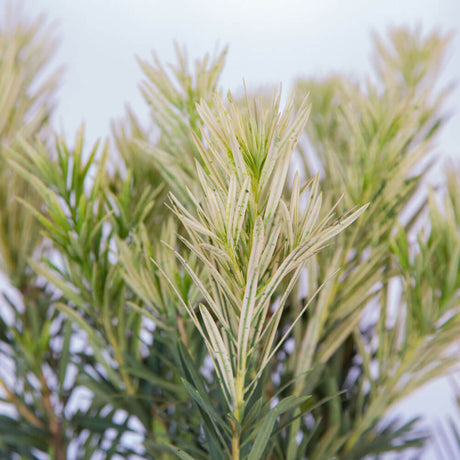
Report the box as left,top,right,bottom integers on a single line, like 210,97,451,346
166,89,364,428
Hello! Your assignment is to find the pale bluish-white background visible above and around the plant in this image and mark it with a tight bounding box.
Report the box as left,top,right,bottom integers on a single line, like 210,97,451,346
11,0,460,459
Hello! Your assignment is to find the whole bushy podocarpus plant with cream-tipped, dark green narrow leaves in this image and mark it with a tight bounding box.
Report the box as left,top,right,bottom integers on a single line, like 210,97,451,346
0,7,460,460
